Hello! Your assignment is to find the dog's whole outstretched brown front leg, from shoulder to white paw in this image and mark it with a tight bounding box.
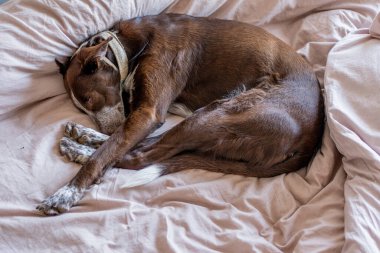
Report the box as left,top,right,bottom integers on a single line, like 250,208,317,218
37,50,189,215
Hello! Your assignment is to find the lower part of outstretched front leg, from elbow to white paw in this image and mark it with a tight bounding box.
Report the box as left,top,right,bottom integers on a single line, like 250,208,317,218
37,107,159,215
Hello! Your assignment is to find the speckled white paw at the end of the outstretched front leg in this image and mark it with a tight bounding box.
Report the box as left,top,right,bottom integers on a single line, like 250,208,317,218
36,185,84,215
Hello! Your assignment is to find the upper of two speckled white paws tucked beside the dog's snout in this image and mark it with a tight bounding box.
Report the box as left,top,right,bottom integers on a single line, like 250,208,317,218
64,122,109,148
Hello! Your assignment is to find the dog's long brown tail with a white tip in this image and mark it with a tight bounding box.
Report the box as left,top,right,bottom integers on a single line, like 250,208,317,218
123,154,308,188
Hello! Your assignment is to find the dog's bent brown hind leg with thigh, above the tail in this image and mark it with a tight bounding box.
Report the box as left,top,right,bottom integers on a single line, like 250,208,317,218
120,90,308,177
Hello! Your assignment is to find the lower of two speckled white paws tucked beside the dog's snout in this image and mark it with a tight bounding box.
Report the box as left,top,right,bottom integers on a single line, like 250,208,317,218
59,137,95,165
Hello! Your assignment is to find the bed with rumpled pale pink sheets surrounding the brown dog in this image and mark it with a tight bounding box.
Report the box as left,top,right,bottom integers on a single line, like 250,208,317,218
0,0,380,253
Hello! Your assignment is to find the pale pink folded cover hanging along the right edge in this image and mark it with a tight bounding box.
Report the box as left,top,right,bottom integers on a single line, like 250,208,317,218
325,13,380,252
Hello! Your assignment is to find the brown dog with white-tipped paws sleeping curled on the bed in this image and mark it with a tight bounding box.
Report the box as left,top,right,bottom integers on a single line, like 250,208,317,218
37,14,324,215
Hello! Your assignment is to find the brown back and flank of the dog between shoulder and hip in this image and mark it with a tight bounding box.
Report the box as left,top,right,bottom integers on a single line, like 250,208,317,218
117,14,319,106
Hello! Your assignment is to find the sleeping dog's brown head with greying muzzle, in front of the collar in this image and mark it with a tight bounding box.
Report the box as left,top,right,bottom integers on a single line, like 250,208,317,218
56,37,125,134
